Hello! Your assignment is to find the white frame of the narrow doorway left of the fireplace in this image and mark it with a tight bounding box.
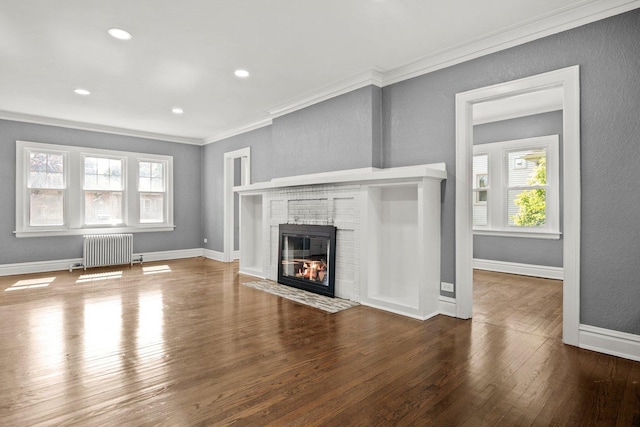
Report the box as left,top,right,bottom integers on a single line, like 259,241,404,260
223,147,251,262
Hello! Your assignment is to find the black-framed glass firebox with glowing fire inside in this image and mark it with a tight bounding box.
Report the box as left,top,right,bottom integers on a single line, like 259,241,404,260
278,224,336,297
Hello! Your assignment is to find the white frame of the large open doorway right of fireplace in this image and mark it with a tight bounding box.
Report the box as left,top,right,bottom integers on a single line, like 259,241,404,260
455,65,581,346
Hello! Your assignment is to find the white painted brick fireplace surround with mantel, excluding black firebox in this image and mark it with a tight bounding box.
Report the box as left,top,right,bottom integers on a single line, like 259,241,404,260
234,163,447,319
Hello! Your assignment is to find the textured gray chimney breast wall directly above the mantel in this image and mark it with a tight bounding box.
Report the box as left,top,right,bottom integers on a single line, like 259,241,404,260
272,86,382,178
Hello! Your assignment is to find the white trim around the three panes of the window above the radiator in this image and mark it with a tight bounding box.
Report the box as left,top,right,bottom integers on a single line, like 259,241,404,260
14,141,175,238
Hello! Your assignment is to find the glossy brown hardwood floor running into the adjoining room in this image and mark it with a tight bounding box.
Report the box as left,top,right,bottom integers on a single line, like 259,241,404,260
0,258,640,426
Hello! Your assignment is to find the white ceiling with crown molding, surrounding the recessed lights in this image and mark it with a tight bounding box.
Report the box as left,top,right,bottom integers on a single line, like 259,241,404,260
0,0,640,144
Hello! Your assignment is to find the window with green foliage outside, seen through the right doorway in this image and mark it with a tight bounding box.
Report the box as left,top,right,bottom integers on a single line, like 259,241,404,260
473,135,560,239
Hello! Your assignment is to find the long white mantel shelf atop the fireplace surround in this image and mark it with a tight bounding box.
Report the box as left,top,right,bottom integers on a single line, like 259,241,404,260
233,163,447,194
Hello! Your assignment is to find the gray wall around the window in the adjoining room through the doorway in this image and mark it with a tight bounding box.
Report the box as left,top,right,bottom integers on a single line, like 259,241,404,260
473,111,563,267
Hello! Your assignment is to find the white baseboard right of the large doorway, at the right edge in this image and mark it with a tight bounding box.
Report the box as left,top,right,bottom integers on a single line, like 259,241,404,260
579,325,640,362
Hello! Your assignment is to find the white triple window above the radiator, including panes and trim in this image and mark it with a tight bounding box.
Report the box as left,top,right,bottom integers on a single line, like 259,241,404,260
16,141,173,237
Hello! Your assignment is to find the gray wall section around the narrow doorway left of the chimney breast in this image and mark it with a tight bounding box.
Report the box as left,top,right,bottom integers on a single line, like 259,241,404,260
200,126,274,252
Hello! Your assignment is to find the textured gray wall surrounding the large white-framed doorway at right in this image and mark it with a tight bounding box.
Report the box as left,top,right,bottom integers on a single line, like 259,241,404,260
382,9,640,334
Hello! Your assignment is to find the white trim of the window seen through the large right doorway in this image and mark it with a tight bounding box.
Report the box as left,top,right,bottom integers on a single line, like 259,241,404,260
473,135,562,240
